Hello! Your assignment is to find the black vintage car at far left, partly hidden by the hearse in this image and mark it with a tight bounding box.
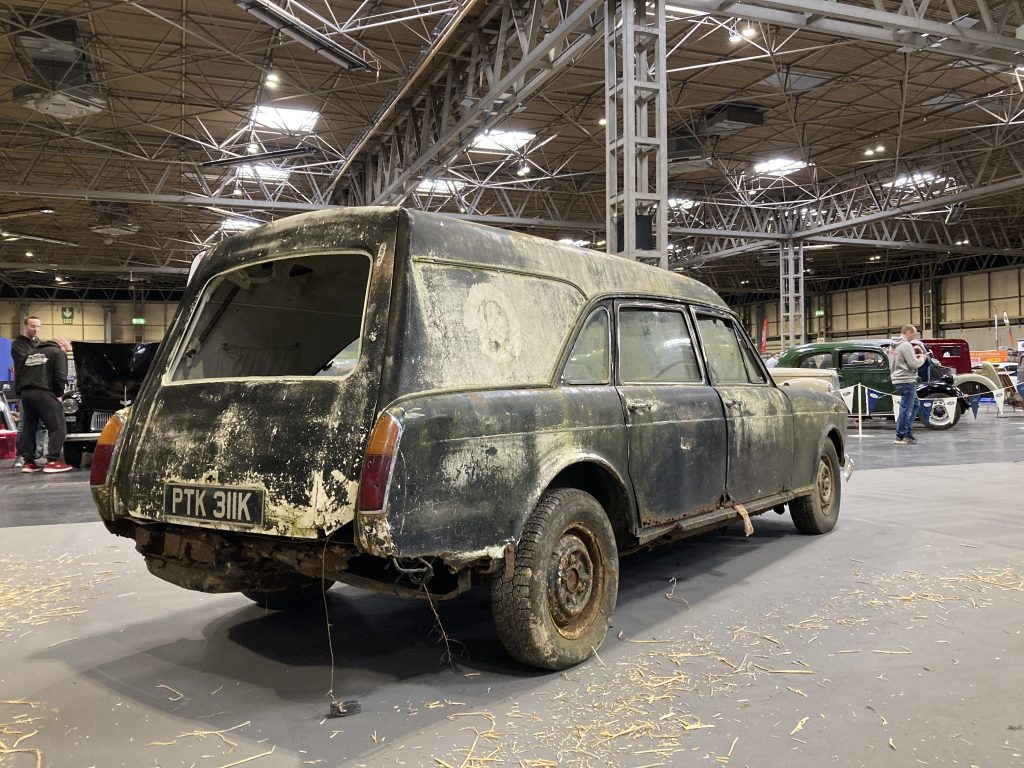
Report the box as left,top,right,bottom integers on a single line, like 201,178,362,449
62,341,160,467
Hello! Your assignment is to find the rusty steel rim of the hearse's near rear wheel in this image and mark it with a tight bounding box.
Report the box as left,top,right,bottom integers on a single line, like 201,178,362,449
548,528,600,638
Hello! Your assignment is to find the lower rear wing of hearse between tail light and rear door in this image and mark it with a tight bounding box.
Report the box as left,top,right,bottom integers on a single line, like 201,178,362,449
378,386,632,559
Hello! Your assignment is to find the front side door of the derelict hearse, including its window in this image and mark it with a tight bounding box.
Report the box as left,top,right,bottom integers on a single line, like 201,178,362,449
694,310,794,503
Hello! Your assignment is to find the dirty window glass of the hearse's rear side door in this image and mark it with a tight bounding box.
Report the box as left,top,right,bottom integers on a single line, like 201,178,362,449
618,308,703,384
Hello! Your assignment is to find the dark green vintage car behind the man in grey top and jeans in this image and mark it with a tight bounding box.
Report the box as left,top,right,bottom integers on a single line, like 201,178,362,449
778,341,970,429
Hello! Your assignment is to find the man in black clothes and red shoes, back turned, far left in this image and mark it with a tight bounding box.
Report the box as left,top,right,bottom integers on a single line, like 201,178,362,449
15,338,72,474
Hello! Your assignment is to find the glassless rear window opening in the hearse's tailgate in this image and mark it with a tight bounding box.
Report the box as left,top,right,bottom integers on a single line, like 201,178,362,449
171,253,370,381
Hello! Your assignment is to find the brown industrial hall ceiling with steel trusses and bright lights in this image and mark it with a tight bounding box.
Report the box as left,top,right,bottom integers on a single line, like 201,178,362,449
0,0,1024,300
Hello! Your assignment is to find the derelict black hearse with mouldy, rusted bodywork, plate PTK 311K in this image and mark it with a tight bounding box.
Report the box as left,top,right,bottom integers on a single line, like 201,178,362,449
90,208,851,670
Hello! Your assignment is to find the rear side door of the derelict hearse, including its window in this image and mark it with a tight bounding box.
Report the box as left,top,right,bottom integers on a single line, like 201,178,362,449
615,301,727,525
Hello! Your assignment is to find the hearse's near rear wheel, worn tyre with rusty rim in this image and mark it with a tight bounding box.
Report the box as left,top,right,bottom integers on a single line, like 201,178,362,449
492,488,618,670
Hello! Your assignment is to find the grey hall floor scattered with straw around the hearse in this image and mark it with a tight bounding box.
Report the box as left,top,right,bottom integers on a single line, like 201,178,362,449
0,410,1024,768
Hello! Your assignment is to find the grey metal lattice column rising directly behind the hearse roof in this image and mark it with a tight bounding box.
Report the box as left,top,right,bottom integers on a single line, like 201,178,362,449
604,0,669,268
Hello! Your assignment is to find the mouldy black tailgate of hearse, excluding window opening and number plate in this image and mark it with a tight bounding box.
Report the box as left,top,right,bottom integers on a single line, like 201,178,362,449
114,209,400,539
